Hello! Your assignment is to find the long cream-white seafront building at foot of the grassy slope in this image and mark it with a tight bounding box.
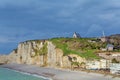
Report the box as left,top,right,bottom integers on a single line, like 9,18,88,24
86,59,110,70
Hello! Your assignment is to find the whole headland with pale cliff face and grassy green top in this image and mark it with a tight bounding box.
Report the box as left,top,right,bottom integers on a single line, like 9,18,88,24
2,38,119,68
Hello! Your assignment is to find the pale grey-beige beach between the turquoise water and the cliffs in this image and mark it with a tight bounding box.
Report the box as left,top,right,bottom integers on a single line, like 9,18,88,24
0,64,120,80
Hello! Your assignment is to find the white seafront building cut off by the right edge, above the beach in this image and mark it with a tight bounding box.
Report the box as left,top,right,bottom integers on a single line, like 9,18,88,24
110,63,120,75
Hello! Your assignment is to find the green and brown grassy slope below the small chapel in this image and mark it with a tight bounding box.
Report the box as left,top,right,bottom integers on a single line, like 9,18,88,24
50,38,105,59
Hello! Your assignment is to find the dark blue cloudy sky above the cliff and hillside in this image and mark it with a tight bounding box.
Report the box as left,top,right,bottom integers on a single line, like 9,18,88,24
0,0,120,54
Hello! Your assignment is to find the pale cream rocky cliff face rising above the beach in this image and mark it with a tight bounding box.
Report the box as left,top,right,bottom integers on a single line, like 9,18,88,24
8,40,85,68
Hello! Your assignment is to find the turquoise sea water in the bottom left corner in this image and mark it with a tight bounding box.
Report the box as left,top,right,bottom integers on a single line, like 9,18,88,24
0,68,48,80
